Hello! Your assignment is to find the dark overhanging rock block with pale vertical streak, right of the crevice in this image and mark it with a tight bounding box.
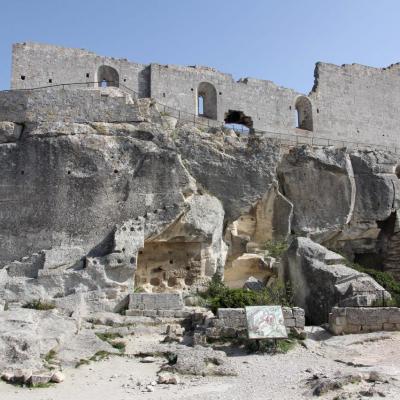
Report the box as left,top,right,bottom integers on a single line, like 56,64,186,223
278,146,400,274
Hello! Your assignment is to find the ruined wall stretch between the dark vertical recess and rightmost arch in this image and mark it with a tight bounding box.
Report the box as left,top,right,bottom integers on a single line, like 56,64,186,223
151,64,300,133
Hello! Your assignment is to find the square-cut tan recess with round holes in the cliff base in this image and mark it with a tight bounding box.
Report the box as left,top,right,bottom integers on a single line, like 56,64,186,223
135,242,204,293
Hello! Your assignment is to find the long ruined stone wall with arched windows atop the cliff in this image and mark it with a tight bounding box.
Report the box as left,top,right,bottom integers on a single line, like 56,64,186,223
7,43,400,147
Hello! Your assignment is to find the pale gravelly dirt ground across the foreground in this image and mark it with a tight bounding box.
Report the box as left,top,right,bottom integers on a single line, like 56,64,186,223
0,328,400,400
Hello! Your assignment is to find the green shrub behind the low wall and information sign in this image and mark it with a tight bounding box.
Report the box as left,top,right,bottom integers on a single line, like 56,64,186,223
202,277,292,312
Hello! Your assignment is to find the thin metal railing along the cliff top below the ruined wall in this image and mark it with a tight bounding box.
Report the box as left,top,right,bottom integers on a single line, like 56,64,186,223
0,81,400,154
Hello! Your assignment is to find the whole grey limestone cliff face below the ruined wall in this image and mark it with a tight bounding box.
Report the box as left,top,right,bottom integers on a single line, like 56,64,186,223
0,96,399,312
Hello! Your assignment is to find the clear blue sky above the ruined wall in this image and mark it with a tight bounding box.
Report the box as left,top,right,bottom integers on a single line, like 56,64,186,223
0,0,400,93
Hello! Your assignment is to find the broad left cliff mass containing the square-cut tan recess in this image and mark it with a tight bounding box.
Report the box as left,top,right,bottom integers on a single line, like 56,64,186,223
0,100,280,312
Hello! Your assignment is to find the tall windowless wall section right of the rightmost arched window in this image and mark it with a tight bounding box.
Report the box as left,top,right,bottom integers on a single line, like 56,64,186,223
310,63,400,146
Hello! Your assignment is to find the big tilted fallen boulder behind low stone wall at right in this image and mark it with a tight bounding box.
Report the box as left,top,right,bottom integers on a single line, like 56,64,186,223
284,237,390,324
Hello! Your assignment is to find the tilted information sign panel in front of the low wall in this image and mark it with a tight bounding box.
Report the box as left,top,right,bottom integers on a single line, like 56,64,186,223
246,306,287,339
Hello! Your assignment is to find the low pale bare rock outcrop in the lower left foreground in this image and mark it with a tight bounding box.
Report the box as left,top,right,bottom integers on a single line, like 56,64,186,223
0,308,111,372
